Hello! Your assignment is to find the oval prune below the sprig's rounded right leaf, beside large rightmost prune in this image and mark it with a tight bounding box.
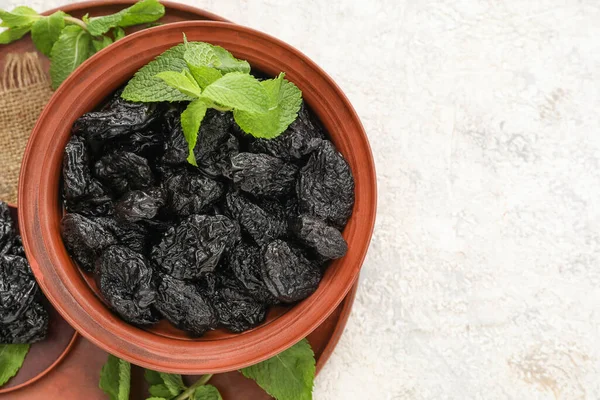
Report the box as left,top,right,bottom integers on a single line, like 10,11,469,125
231,153,298,198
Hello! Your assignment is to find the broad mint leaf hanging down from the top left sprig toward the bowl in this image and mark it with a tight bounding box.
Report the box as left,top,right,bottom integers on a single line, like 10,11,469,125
50,25,92,89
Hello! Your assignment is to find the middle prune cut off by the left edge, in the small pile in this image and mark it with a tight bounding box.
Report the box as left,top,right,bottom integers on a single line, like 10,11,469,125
0,255,38,325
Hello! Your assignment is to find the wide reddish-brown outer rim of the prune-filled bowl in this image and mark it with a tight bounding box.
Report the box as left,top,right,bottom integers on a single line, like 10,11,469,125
18,21,377,374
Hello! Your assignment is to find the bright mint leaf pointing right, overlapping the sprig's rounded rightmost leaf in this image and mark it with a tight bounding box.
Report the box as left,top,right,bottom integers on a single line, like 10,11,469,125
202,72,269,113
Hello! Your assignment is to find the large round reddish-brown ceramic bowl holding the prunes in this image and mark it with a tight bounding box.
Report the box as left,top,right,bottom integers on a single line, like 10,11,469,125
18,22,376,374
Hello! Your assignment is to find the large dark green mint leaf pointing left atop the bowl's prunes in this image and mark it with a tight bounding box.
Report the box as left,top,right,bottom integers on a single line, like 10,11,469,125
121,43,193,102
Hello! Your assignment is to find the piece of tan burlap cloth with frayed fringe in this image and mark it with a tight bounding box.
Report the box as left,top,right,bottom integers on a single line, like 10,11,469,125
0,52,52,204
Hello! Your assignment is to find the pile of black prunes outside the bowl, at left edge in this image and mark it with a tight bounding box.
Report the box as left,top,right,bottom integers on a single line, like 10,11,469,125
0,202,48,344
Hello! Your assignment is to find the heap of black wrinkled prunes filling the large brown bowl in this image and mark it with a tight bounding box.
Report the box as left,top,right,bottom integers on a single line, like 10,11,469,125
62,92,354,336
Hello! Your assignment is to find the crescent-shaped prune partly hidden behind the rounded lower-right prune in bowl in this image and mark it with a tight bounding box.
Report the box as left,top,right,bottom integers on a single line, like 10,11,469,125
227,243,277,304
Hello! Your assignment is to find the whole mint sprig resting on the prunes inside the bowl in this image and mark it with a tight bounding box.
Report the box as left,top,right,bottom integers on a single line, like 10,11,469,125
121,34,302,166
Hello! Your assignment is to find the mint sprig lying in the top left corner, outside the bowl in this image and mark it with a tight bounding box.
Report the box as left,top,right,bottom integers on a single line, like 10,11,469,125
0,0,165,89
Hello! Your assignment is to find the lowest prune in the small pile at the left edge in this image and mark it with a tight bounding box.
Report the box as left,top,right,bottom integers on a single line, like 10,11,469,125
0,302,49,344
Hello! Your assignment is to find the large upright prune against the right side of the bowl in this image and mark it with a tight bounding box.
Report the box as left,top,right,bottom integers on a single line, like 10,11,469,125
296,140,354,229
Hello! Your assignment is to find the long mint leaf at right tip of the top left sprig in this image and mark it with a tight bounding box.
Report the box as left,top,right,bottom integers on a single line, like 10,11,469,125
88,0,165,36
